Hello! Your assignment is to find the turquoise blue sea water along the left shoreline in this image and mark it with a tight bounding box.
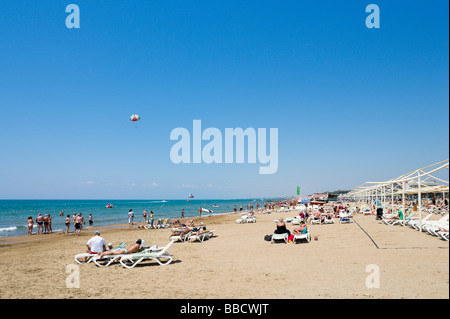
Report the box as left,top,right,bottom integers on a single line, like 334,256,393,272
0,199,264,237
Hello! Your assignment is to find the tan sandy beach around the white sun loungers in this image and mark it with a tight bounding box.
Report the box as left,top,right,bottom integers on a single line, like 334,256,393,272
0,211,449,299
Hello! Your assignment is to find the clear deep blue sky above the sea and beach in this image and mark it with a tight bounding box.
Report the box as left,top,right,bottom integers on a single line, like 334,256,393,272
0,0,449,199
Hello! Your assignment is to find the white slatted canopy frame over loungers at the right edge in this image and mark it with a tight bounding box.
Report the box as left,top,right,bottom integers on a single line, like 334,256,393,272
340,159,449,229
